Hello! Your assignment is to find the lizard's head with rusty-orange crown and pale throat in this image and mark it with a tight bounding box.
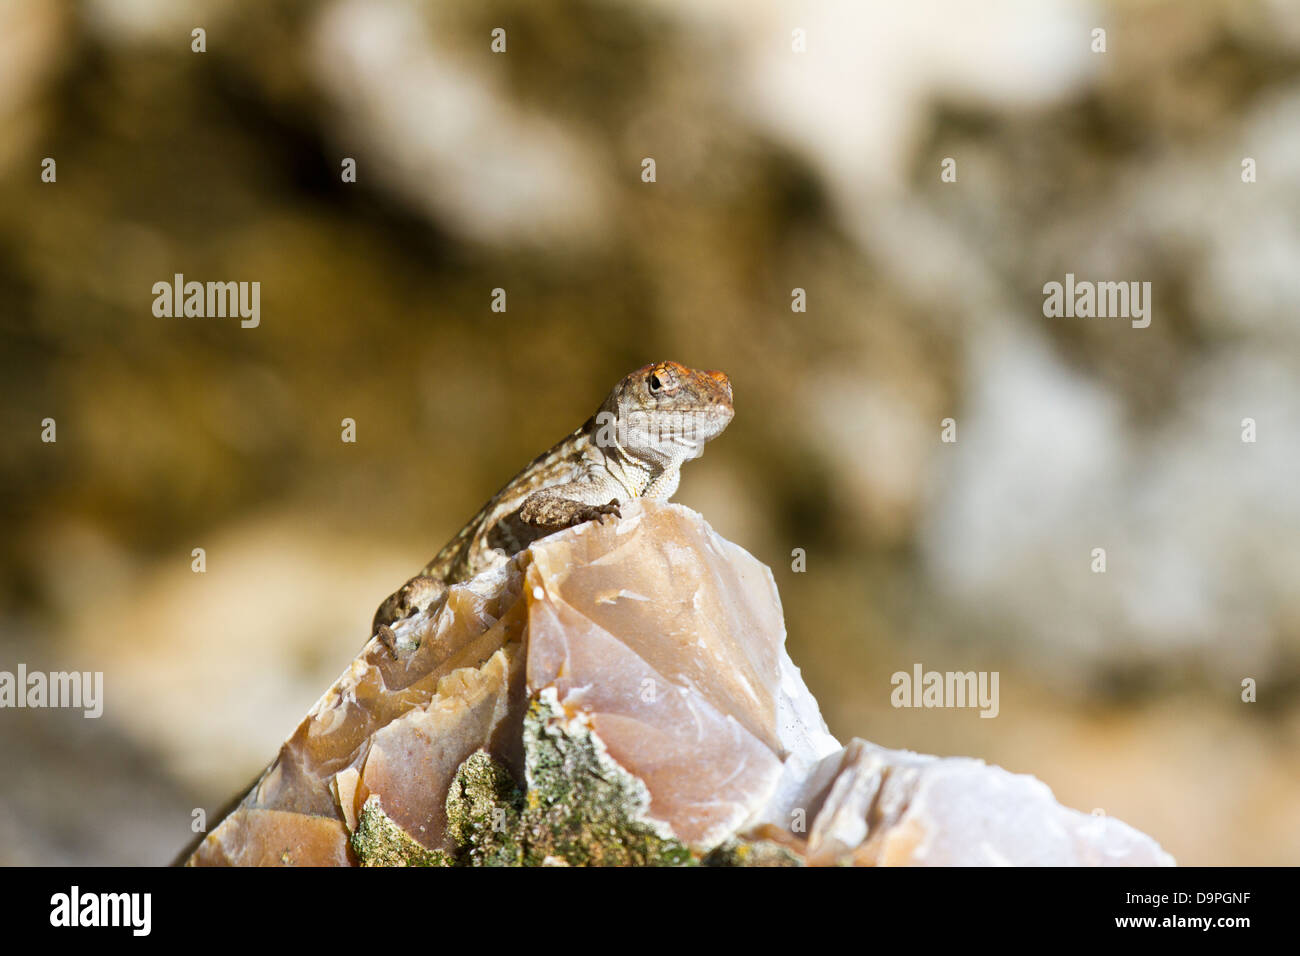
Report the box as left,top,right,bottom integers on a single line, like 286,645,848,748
602,362,736,464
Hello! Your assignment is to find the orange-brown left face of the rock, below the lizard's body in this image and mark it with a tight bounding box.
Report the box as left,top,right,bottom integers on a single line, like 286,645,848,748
189,568,527,865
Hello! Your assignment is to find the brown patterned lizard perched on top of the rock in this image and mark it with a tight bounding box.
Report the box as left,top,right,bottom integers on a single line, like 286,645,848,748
371,362,735,656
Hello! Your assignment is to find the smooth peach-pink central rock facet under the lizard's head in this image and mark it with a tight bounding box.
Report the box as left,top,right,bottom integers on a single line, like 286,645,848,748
525,506,839,848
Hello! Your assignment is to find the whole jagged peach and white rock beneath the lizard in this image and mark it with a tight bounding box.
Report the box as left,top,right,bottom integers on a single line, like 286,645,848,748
187,503,1173,865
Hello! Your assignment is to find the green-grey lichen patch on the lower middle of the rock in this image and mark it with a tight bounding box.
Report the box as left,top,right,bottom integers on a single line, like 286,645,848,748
447,688,696,866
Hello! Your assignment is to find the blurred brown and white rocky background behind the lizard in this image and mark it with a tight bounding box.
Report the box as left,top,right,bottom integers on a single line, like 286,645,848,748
0,0,1300,864
